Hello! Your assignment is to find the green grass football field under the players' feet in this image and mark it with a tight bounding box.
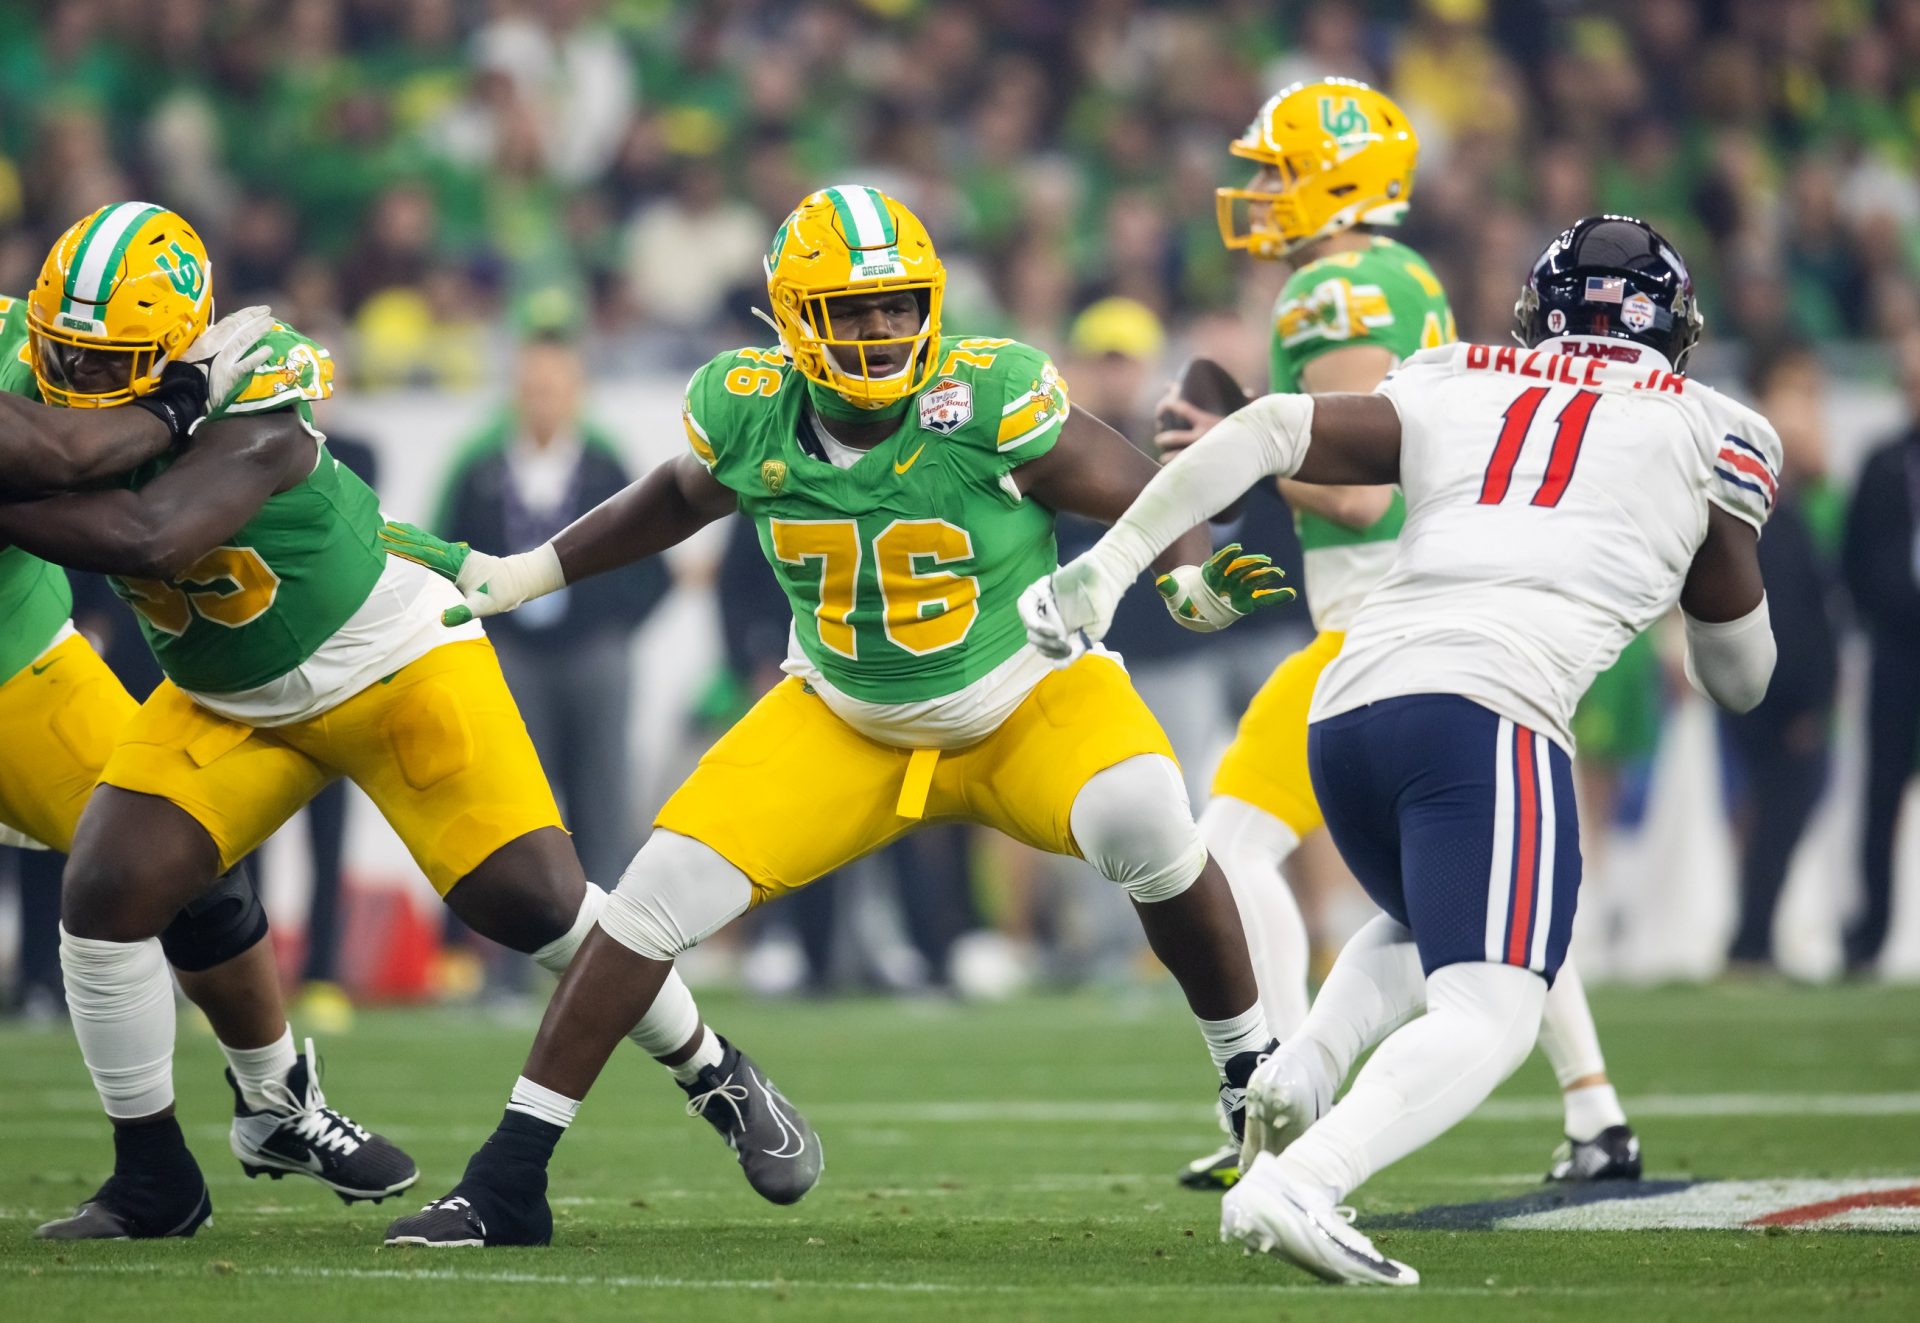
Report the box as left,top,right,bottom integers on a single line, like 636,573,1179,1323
0,985,1920,1323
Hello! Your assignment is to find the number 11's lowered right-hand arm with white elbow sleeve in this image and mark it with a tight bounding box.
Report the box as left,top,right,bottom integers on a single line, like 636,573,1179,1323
1680,505,1778,712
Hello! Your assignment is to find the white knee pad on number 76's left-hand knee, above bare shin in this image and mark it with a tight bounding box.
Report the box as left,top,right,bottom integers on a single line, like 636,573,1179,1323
599,828,753,960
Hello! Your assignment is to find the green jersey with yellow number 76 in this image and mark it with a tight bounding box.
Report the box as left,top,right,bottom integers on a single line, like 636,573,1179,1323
685,336,1068,703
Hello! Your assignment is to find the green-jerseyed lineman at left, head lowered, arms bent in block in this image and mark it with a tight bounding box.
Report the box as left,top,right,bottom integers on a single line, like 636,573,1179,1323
0,202,794,1237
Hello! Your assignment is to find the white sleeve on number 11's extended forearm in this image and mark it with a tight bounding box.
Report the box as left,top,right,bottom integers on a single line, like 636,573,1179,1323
1087,396,1313,586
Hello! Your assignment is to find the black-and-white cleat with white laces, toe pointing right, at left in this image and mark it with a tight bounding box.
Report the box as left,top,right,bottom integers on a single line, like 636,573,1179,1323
227,1039,420,1204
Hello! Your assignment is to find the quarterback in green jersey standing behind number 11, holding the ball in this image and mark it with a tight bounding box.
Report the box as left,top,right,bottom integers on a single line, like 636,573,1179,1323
1156,79,1640,1189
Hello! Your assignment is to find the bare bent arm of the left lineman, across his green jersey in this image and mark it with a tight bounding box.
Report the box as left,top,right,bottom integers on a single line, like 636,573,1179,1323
0,409,315,578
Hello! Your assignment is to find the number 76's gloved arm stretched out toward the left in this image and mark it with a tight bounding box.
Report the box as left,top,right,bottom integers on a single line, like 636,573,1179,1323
380,455,735,626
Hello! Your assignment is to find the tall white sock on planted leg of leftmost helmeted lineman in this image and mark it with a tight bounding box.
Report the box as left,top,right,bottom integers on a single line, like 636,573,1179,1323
60,927,173,1121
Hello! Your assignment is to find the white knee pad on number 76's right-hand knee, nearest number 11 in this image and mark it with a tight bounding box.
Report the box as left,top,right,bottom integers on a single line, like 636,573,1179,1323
1068,753,1206,904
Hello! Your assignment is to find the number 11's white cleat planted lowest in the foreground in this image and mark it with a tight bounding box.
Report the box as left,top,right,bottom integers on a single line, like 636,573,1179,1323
1219,1154,1421,1287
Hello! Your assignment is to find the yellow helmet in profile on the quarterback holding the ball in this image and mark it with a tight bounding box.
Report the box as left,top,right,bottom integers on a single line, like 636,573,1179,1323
1213,79,1421,257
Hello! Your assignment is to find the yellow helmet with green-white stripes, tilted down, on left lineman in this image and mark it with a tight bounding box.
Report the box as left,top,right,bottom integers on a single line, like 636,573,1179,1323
27,202,213,409
